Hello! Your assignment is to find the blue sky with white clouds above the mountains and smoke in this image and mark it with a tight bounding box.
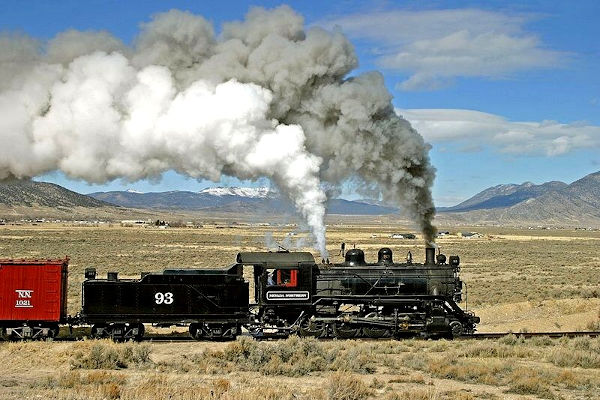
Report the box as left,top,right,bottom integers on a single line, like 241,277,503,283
0,0,600,206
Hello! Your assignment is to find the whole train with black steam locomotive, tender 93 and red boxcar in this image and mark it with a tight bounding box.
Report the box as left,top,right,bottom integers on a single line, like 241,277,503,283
0,248,479,340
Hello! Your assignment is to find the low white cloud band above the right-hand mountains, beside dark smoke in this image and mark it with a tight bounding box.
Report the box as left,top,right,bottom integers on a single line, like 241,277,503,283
396,109,600,156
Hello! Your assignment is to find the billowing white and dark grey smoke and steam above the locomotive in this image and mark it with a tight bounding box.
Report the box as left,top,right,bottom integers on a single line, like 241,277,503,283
0,6,435,250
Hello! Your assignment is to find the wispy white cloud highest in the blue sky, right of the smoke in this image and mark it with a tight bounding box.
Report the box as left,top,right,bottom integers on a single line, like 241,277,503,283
320,9,566,90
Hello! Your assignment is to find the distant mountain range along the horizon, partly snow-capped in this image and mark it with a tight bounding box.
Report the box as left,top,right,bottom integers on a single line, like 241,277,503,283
0,172,600,226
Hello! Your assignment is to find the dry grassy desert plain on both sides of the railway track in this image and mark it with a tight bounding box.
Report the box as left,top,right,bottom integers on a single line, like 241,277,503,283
0,218,600,399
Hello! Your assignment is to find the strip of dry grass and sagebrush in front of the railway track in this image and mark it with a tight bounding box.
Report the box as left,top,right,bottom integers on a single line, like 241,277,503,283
0,336,600,400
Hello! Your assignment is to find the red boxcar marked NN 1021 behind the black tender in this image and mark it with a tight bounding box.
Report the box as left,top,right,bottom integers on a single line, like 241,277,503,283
0,258,69,338
